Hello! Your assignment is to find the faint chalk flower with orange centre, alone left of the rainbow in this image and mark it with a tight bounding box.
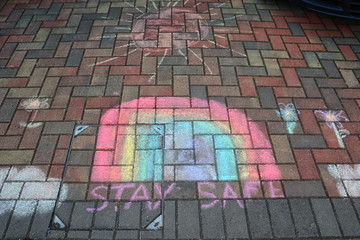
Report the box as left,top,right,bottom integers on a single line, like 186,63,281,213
19,96,49,128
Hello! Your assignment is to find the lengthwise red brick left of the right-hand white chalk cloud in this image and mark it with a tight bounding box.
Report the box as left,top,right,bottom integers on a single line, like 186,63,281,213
294,149,320,180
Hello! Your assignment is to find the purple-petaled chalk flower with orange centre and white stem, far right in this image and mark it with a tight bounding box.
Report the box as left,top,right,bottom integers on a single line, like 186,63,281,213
315,110,350,148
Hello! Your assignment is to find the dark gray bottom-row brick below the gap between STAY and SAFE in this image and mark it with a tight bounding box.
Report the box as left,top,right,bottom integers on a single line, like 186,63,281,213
177,201,200,239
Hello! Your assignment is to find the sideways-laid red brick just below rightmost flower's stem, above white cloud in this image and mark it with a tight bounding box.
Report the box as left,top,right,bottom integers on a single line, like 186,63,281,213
312,149,351,163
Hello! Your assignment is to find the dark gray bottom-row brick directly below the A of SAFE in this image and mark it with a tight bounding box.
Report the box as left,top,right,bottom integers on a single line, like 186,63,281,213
224,200,249,239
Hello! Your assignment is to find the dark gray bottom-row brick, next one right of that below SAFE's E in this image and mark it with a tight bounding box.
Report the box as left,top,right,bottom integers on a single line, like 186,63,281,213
290,199,319,238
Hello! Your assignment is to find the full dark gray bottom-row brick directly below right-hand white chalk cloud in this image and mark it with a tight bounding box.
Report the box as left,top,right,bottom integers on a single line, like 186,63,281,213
332,198,360,237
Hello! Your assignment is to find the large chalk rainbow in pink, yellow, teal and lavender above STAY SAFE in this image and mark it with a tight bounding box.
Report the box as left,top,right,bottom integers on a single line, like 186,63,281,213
91,97,281,182
